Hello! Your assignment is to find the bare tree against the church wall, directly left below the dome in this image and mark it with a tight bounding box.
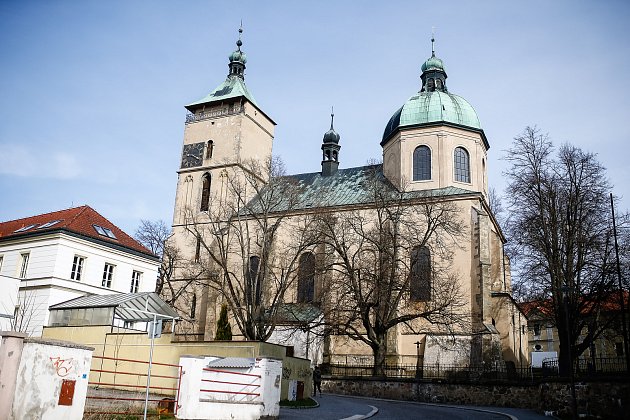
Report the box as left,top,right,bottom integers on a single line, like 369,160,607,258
319,166,469,376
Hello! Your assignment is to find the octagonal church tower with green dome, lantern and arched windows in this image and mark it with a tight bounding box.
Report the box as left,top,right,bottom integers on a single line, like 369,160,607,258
381,38,490,198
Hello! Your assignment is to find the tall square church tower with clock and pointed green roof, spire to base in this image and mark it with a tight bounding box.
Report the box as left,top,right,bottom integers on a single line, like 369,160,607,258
169,28,275,338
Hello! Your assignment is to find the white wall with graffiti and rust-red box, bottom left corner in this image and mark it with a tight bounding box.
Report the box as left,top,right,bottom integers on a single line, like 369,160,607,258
0,332,93,420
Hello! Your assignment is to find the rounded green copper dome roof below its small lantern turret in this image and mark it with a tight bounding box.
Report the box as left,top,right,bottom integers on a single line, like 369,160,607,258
381,90,481,144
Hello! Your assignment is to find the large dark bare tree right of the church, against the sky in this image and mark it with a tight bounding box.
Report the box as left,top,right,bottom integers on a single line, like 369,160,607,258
505,127,627,374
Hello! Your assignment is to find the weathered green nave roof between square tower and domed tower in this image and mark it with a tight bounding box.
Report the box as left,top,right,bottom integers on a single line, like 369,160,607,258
250,165,478,212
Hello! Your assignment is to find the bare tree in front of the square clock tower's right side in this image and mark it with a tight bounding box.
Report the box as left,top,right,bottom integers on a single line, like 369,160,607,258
187,159,316,341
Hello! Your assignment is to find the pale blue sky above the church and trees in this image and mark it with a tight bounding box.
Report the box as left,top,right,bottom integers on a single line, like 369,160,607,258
0,0,630,234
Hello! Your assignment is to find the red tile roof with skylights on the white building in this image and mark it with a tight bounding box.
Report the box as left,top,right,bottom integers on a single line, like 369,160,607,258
0,206,155,257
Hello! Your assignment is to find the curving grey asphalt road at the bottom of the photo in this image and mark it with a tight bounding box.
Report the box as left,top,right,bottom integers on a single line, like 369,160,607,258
280,394,549,420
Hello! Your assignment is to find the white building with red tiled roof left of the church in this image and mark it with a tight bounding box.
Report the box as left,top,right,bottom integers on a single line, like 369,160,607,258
0,206,160,336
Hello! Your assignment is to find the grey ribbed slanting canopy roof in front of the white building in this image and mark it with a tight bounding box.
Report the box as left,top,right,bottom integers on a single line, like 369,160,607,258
49,292,179,322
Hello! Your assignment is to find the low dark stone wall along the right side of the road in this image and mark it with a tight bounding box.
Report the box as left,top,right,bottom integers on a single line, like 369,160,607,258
322,378,630,419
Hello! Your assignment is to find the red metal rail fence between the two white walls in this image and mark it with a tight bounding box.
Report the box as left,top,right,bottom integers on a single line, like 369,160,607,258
85,356,182,419
